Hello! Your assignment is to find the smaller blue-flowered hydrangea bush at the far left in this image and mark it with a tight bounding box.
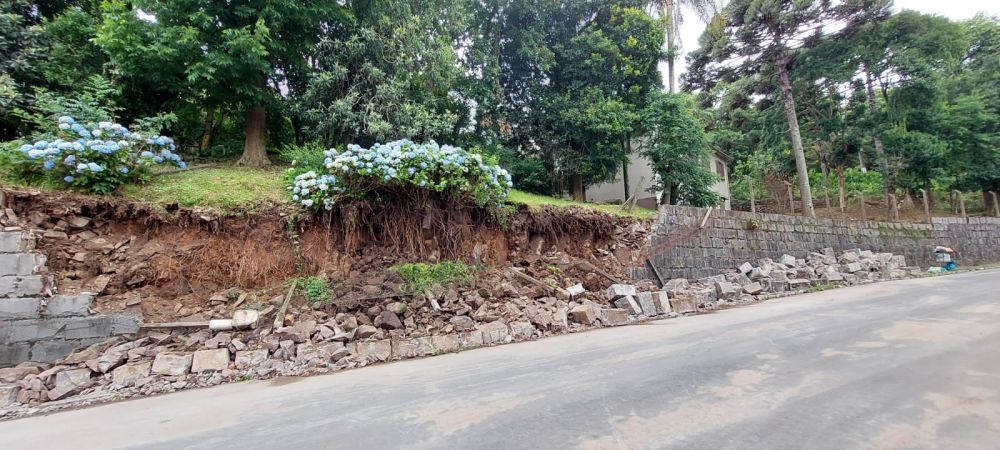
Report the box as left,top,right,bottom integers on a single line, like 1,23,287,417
12,116,187,194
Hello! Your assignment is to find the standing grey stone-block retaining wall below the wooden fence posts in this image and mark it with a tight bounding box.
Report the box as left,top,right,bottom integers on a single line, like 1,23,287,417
631,206,1000,279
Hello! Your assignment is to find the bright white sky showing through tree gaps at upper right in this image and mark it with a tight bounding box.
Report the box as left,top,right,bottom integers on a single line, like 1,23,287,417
660,0,1000,88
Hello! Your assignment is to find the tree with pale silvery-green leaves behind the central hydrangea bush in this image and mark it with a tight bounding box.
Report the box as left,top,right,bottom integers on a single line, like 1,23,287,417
301,0,465,145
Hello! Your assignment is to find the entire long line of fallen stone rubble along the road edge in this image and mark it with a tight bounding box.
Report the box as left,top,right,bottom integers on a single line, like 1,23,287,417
0,249,920,417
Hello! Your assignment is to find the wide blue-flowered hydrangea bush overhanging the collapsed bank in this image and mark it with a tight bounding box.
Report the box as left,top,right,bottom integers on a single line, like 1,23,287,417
288,140,513,209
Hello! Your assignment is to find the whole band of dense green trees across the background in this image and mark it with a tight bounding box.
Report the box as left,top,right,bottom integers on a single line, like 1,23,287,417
0,0,1000,209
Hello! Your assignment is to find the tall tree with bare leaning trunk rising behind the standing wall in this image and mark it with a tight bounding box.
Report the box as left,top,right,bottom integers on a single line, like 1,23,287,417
693,0,848,217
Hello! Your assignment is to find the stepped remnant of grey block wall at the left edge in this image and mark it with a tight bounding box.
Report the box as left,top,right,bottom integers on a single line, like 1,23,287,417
0,227,138,367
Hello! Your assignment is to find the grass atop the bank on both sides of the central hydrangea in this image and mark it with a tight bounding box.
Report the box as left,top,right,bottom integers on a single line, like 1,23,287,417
115,167,654,219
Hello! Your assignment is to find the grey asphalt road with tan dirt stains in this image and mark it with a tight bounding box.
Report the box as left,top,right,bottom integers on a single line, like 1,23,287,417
0,271,1000,450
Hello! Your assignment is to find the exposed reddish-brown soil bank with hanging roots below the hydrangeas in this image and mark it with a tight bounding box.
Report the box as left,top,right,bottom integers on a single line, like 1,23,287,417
3,190,650,322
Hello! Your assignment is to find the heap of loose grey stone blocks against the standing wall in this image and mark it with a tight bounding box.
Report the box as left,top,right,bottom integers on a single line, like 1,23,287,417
663,248,922,310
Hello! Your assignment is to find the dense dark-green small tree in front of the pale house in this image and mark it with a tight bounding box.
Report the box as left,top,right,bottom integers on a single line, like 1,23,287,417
642,93,719,206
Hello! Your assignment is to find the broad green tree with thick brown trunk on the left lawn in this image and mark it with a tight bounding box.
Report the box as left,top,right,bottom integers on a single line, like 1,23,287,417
96,0,342,167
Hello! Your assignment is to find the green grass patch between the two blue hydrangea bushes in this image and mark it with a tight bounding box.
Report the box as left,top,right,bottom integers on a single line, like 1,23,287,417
120,167,288,212
